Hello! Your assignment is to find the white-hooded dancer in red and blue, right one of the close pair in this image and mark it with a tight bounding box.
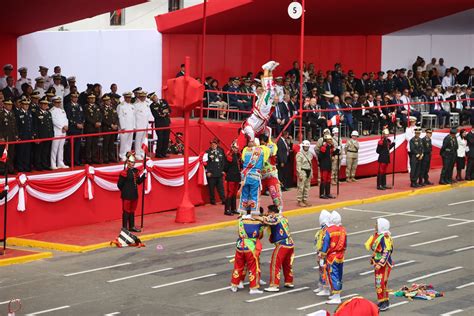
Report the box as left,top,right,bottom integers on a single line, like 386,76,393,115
320,211,347,305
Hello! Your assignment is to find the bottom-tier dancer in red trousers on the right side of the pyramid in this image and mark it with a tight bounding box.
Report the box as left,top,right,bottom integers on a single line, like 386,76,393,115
264,205,295,292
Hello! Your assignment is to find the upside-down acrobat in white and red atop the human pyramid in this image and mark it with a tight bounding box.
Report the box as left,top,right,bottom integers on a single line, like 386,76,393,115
237,60,279,148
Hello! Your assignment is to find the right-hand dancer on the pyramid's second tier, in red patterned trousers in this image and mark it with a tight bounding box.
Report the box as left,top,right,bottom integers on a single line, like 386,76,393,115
259,135,283,213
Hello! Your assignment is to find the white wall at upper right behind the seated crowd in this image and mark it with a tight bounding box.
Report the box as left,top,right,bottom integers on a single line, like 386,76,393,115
382,34,474,71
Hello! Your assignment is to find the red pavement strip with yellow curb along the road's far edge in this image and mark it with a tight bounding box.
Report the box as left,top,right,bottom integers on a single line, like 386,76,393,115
8,169,474,252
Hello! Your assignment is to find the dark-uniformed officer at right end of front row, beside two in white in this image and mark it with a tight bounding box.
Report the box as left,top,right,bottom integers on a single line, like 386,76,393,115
148,92,171,158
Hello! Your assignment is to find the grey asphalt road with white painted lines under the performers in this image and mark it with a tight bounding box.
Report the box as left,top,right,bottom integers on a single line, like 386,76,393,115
0,188,474,315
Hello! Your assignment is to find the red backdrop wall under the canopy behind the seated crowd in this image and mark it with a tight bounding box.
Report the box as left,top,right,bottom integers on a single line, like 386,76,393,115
163,34,382,86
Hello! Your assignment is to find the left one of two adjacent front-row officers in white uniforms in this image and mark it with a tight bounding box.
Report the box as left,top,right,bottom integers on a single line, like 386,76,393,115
117,92,135,161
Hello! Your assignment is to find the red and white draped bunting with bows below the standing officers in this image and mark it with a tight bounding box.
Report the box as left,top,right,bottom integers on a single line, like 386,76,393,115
0,157,207,212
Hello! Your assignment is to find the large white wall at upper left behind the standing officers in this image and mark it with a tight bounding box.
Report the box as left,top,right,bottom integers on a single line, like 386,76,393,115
18,30,162,95
